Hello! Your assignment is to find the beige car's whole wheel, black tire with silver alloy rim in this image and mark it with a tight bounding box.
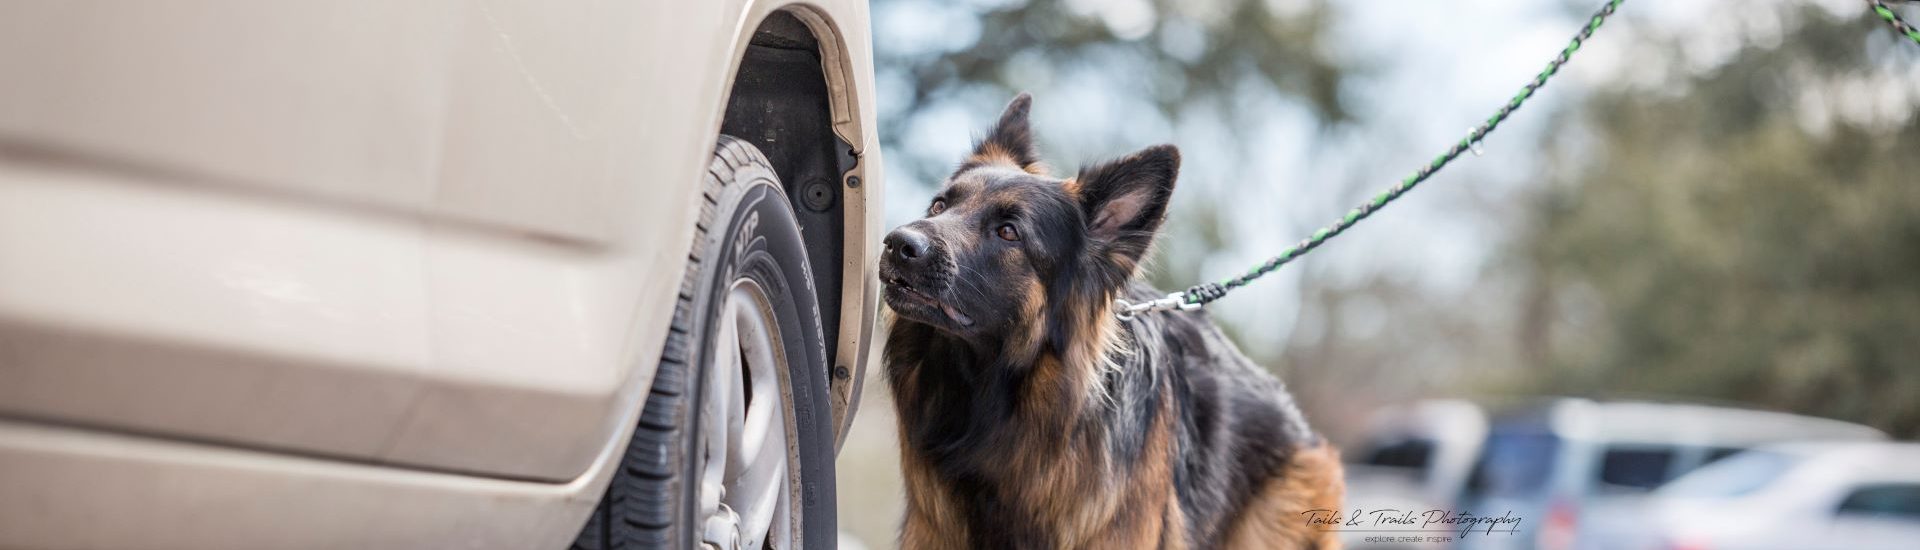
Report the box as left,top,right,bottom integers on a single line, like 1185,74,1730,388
574,137,837,550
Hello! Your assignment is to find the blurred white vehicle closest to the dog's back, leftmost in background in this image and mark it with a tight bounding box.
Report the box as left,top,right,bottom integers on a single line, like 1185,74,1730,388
1344,400,1486,548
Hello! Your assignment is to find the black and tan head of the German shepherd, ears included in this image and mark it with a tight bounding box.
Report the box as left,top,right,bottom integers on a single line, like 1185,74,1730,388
879,94,1181,356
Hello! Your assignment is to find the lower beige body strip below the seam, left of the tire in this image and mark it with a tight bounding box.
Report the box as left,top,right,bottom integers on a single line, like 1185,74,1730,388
0,419,624,550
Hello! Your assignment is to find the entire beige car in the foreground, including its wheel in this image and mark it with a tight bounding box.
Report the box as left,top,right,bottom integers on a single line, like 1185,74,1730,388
0,0,883,548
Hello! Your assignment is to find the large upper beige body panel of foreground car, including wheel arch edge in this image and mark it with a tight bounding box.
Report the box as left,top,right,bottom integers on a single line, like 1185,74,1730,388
0,0,881,490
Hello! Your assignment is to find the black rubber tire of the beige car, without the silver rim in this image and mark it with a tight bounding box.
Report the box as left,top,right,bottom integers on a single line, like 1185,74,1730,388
572,135,839,550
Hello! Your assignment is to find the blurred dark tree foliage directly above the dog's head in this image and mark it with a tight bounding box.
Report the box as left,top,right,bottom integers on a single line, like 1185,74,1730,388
876,0,1348,183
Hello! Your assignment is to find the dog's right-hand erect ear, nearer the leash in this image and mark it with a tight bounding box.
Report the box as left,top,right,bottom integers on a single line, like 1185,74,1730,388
1068,144,1181,273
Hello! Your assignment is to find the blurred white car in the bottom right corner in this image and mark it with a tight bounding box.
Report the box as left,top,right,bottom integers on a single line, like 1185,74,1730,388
1611,442,1920,550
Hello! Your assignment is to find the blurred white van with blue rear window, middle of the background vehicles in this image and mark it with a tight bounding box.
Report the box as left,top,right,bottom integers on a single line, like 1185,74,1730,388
1459,398,1885,550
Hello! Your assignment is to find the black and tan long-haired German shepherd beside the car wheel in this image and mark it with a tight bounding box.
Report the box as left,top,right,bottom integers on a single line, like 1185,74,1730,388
879,94,1342,548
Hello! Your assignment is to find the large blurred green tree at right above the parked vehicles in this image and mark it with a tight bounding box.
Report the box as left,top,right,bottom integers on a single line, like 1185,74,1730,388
1509,4,1920,437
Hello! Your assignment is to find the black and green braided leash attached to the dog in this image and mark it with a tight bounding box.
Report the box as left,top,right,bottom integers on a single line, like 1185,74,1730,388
1116,0,1920,319
